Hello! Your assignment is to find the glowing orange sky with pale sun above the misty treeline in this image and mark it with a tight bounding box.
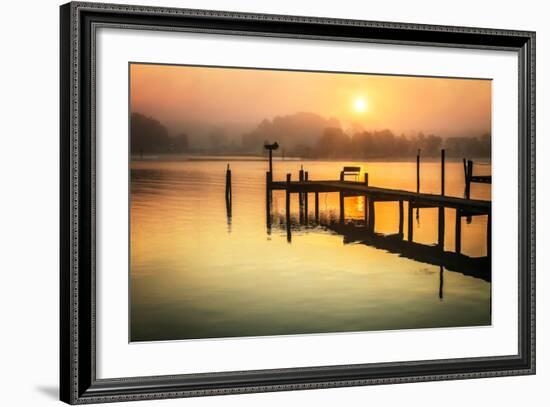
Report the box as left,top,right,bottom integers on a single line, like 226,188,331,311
130,64,491,136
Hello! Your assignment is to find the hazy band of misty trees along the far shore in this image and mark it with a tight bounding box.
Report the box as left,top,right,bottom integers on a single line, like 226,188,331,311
130,113,491,159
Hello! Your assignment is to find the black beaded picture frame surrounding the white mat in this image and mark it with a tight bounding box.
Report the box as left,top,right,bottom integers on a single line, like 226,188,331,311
60,2,535,404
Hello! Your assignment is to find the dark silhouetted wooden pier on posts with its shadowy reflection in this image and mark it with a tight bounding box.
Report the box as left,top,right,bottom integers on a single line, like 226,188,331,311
256,150,491,281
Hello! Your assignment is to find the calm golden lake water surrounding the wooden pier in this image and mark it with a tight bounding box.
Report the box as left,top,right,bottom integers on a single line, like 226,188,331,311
130,159,491,341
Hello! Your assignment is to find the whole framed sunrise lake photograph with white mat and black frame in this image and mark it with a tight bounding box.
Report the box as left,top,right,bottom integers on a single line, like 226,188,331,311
60,2,535,404
